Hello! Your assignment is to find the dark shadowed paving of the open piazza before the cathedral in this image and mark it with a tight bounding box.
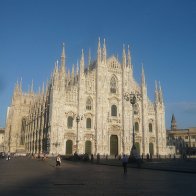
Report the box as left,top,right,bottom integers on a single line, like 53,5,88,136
0,158,196,196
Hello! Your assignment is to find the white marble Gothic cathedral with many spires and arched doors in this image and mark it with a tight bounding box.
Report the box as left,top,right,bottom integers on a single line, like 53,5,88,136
5,39,166,155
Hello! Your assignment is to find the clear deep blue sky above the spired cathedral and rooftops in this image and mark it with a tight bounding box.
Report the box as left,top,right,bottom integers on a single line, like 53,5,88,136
0,0,196,128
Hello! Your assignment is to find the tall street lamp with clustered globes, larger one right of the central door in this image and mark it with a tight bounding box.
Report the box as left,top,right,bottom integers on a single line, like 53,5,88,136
124,92,142,149
